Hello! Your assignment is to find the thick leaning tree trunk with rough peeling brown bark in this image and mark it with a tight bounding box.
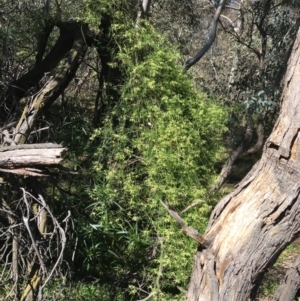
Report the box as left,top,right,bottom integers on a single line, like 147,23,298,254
186,30,300,301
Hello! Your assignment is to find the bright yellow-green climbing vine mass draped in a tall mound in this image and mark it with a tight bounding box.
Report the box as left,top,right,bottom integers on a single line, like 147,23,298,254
85,23,226,300
